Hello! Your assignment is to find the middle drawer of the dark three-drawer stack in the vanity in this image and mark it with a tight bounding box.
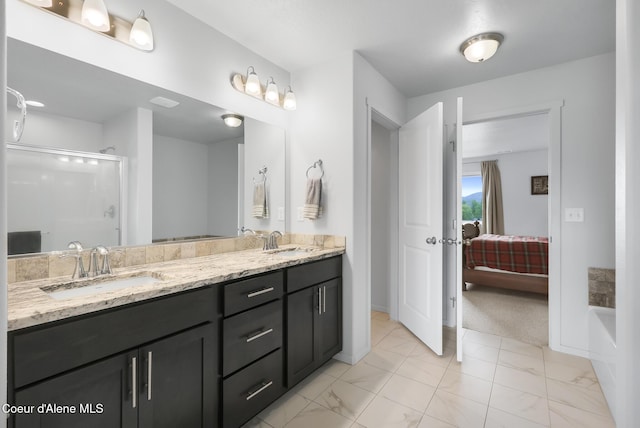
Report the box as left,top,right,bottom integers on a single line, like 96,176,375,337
222,300,282,376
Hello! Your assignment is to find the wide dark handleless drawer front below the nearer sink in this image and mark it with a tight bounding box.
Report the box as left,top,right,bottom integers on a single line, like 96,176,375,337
9,287,218,388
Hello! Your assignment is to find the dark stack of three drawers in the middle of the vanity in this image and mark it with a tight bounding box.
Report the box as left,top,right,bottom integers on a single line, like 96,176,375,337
222,271,285,427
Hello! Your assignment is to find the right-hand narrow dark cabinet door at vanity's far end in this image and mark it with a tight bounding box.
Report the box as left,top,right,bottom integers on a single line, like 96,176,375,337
317,278,342,364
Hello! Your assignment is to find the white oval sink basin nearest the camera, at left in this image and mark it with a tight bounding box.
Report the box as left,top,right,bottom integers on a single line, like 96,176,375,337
41,272,162,300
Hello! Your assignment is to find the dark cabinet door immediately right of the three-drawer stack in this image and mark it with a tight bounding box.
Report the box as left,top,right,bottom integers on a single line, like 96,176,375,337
287,287,319,388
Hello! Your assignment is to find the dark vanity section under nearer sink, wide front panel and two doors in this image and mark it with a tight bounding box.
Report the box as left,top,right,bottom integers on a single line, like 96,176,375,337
9,288,218,428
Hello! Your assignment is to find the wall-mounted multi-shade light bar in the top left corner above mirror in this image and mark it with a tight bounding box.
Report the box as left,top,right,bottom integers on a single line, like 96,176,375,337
22,0,154,52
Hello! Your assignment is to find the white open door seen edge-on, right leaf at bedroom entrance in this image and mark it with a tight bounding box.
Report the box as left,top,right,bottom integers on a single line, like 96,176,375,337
455,97,464,361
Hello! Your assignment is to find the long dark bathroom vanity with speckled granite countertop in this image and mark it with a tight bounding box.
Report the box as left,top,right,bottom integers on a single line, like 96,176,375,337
9,249,344,428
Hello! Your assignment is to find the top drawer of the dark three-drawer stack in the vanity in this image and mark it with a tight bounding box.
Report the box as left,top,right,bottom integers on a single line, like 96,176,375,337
224,271,284,317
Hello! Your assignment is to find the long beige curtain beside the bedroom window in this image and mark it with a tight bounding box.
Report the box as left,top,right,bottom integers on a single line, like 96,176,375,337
482,161,504,235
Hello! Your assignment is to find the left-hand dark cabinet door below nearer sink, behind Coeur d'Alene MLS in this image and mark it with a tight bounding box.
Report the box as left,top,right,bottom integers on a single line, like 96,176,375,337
10,352,138,428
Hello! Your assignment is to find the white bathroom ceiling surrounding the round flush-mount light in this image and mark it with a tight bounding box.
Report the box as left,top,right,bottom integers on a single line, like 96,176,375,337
168,0,615,97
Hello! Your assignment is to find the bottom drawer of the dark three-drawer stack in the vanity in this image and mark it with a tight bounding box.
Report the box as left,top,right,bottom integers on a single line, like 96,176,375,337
222,349,284,428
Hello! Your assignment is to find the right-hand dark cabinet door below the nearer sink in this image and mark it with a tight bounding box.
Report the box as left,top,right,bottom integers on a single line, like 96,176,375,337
139,324,218,428
